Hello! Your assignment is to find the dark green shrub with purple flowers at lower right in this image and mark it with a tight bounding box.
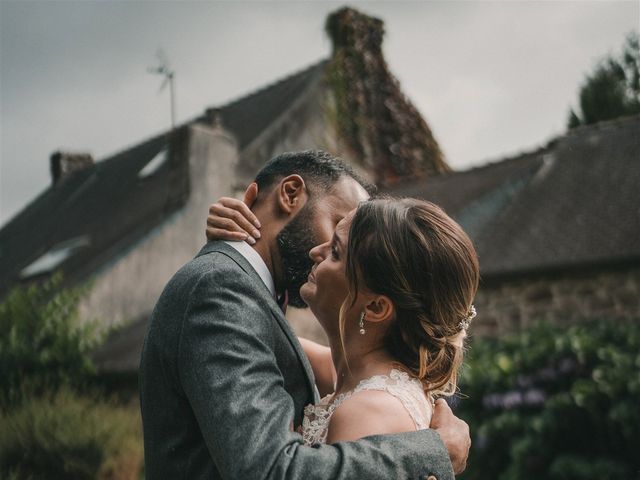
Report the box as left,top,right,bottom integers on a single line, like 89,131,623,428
458,321,640,480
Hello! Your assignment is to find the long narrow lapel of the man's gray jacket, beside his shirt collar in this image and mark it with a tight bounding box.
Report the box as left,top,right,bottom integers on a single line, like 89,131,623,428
196,241,319,403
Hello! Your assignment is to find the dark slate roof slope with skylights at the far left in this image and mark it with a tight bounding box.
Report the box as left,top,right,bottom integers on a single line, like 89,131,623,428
0,130,178,292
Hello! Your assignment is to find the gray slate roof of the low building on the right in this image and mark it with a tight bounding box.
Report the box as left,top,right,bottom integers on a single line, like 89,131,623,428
391,116,640,279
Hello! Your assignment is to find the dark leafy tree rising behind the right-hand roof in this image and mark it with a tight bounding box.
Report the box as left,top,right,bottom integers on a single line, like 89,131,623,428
568,32,640,129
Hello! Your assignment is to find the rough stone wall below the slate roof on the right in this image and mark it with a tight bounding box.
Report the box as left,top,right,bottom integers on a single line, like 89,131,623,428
471,266,640,336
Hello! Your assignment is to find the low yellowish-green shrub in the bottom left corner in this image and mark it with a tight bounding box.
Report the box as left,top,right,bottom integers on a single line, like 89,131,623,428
0,389,143,480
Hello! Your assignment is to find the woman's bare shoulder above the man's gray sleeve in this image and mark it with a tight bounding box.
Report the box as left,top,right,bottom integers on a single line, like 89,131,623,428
327,390,415,443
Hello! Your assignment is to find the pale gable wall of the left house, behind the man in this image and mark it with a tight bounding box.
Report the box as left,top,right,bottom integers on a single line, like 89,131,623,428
80,83,370,334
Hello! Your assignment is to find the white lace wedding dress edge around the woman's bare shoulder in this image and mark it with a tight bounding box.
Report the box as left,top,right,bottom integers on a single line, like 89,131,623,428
302,368,433,446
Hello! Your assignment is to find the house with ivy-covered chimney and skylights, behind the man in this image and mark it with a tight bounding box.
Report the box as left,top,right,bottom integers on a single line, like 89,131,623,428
0,8,450,368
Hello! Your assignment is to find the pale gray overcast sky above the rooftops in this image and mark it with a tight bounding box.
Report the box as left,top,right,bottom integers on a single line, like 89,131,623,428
0,0,640,225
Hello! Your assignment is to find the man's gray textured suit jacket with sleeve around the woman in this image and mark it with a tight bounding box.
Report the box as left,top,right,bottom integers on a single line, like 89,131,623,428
140,242,453,480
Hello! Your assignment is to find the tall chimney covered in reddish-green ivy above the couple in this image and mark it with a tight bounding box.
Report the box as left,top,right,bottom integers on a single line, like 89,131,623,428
325,8,451,186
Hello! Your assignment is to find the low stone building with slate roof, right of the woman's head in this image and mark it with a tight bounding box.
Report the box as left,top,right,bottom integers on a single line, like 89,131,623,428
393,116,640,335
